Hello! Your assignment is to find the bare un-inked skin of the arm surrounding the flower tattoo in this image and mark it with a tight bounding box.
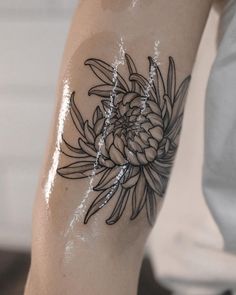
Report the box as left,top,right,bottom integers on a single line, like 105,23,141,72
25,0,214,295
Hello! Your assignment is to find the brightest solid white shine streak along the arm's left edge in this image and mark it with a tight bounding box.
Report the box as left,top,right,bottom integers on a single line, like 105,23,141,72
44,80,71,209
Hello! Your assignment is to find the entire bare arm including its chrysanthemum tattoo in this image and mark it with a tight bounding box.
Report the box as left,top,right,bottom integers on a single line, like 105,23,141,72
26,0,211,295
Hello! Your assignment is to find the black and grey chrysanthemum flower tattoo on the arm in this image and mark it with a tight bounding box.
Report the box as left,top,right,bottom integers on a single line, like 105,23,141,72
57,54,190,225
